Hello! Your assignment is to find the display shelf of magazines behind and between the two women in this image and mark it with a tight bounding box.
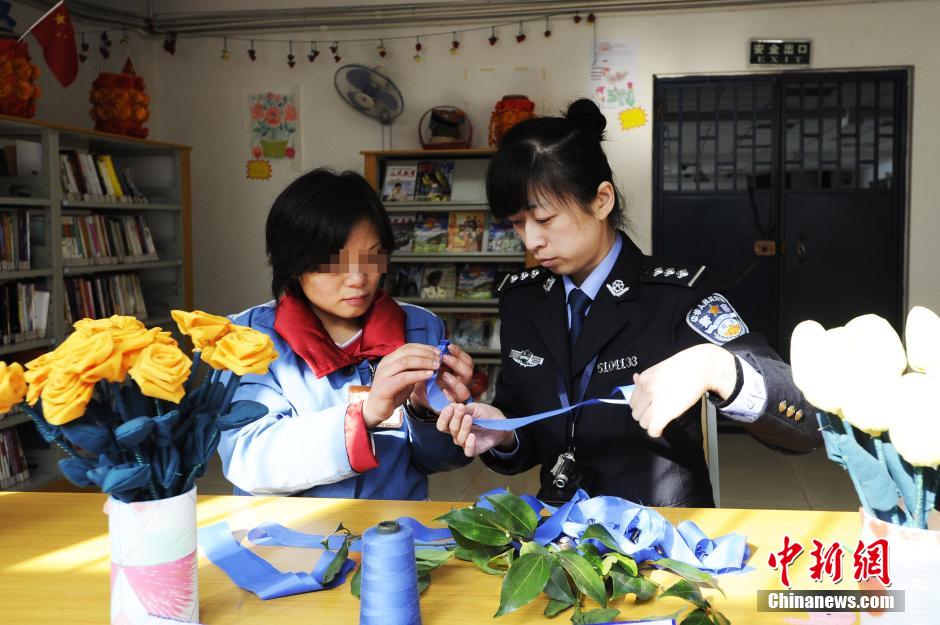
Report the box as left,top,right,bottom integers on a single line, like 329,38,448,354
362,149,534,365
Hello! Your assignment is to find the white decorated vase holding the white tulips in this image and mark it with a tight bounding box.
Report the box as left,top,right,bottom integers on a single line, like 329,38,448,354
850,510,940,625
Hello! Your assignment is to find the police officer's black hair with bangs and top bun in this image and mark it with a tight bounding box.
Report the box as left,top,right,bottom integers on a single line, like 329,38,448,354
486,98,624,228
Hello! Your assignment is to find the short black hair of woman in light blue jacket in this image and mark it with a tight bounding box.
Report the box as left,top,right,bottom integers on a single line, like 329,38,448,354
265,167,395,300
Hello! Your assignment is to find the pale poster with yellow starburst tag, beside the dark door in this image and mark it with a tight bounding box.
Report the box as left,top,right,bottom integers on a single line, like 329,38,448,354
588,41,647,130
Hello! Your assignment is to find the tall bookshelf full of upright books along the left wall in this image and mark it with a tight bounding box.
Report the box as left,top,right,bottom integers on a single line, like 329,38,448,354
0,116,193,490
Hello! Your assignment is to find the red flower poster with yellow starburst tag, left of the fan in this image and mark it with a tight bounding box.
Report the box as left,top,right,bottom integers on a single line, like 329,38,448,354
246,87,303,180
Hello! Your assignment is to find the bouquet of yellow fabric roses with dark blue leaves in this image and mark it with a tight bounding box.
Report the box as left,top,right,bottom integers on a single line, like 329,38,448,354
0,310,278,502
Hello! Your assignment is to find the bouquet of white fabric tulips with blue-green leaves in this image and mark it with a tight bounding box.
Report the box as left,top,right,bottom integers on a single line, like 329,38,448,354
790,306,940,529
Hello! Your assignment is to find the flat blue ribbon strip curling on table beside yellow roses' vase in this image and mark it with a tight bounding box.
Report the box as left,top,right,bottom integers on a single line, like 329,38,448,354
199,521,356,599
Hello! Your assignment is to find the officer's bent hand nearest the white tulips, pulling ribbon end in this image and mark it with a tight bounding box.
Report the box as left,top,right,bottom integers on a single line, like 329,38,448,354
630,343,737,438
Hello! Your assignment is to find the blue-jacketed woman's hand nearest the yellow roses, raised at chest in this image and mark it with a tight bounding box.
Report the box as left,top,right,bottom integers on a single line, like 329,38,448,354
362,343,441,428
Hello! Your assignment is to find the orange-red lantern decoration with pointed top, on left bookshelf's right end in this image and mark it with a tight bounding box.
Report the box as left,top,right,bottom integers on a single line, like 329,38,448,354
91,59,150,139
